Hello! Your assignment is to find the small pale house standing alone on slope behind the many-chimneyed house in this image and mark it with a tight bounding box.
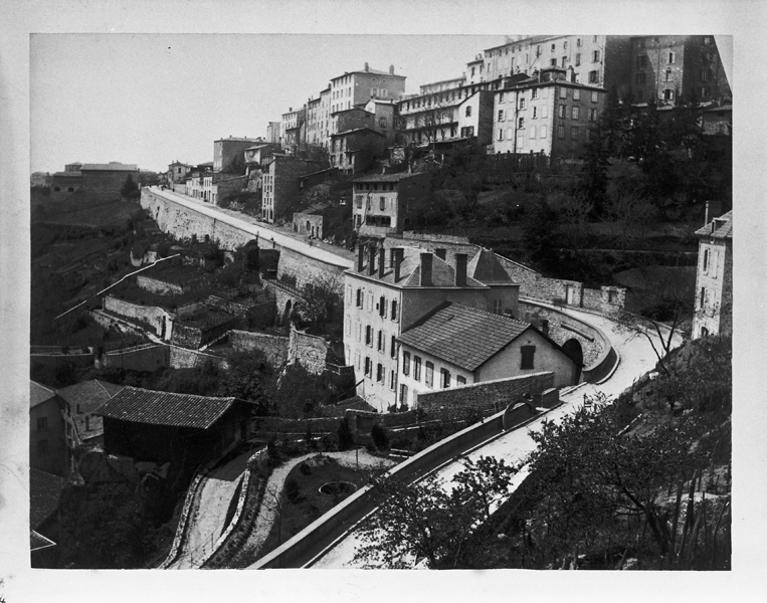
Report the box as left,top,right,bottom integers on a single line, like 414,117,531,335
352,173,430,238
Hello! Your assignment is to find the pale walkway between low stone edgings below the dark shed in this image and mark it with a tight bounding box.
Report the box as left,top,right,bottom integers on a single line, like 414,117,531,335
169,452,250,569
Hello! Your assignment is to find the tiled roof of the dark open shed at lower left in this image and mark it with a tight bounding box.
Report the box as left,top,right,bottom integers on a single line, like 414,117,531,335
97,387,236,429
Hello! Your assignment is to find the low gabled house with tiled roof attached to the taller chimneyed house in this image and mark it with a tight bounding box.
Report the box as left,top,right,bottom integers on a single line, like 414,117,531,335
397,302,581,406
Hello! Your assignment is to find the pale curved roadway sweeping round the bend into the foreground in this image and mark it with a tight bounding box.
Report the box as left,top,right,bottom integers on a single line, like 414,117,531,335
306,308,682,569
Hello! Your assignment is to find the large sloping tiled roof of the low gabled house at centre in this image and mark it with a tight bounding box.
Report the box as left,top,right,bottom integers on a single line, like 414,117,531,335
399,303,531,372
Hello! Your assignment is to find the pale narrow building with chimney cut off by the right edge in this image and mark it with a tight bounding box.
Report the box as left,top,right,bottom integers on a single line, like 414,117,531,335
692,211,732,339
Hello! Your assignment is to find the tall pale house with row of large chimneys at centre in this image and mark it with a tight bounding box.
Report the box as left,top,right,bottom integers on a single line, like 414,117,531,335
344,243,519,411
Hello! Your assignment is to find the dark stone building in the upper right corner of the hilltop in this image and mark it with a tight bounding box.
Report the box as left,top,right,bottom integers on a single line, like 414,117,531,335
630,35,732,104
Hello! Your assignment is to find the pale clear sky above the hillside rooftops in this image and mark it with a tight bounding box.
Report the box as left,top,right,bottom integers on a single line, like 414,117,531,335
30,34,504,172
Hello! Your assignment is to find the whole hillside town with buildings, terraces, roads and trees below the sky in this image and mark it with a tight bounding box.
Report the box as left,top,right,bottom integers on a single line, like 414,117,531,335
29,34,733,570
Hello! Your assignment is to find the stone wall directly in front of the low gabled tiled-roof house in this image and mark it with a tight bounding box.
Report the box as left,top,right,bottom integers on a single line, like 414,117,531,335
418,372,554,419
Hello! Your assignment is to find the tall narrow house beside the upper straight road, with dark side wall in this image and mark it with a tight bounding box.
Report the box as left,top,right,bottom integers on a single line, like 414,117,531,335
261,153,324,223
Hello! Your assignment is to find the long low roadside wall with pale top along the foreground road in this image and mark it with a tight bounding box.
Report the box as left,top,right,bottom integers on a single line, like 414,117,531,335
251,398,560,569
